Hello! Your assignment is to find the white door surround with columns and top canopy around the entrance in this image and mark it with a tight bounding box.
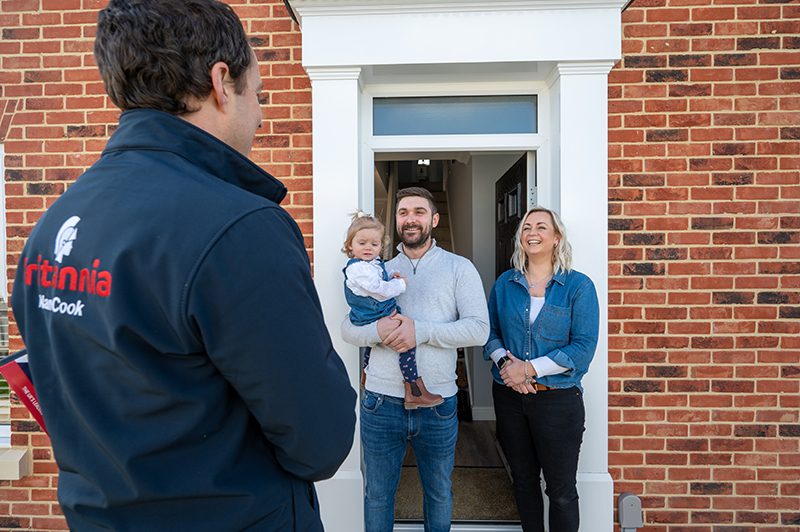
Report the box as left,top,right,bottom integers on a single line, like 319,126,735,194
290,0,625,532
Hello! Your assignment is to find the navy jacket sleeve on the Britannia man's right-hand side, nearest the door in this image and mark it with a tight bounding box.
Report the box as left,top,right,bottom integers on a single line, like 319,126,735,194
185,207,356,481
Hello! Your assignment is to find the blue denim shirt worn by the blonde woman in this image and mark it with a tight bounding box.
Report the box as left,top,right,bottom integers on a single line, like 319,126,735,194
483,269,600,390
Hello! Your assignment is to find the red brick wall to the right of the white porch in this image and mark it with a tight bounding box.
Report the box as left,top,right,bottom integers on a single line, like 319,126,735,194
609,0,800,532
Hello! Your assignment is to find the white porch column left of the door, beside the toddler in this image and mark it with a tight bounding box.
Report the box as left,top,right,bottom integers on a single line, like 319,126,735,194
306,67,364,532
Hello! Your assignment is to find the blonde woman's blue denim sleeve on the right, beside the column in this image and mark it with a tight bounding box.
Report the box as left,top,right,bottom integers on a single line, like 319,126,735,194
547,278,600,371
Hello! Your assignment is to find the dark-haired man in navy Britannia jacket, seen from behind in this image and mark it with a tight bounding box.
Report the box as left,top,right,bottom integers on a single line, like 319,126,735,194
13,0,355,531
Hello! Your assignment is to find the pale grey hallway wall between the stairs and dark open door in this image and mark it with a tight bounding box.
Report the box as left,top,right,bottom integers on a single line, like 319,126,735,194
467,153,521,420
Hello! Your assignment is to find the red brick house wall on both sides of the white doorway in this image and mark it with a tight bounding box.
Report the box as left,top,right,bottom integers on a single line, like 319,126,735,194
0,0,800,532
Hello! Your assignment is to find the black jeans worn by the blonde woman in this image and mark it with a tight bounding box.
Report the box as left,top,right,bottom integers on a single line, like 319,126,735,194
492,382,586,532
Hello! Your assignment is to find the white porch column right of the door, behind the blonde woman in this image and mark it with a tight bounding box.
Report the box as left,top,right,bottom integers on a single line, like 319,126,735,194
543,62,614,532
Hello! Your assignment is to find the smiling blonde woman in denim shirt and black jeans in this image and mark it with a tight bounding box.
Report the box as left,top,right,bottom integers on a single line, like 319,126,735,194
484,207,599,532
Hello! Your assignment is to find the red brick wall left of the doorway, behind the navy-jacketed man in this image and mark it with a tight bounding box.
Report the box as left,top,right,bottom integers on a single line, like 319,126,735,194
0,0,312,530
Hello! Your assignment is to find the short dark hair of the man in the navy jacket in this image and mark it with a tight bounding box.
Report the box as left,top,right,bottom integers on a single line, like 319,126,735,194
94,0,252,115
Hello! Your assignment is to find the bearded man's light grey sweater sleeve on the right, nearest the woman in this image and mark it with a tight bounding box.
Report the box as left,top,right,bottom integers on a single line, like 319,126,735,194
414,259,489,349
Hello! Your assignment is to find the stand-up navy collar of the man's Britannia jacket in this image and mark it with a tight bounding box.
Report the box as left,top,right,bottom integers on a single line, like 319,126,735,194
103,109,286,203
